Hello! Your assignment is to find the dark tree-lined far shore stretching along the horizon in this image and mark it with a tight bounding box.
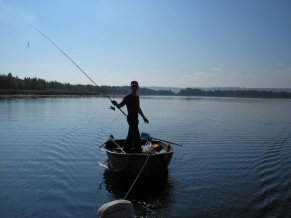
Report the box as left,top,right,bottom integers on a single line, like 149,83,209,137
0,73,291,98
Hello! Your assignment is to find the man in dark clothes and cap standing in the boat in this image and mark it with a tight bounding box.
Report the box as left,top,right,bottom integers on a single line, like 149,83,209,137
111,81,149,153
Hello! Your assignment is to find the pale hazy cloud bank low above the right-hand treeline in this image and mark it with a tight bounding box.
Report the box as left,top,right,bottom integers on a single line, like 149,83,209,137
98,67,291,88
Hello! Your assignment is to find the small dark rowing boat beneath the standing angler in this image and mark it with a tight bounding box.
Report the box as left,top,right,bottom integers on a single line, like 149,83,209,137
102,139,174,180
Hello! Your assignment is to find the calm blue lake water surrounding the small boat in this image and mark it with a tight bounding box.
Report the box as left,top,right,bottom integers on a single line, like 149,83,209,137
0,97,291,218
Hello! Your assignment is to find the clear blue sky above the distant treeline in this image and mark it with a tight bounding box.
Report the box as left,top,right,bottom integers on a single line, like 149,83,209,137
0,0,291,88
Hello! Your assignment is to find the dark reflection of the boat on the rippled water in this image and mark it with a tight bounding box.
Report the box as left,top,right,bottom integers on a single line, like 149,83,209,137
101,169,175,217
